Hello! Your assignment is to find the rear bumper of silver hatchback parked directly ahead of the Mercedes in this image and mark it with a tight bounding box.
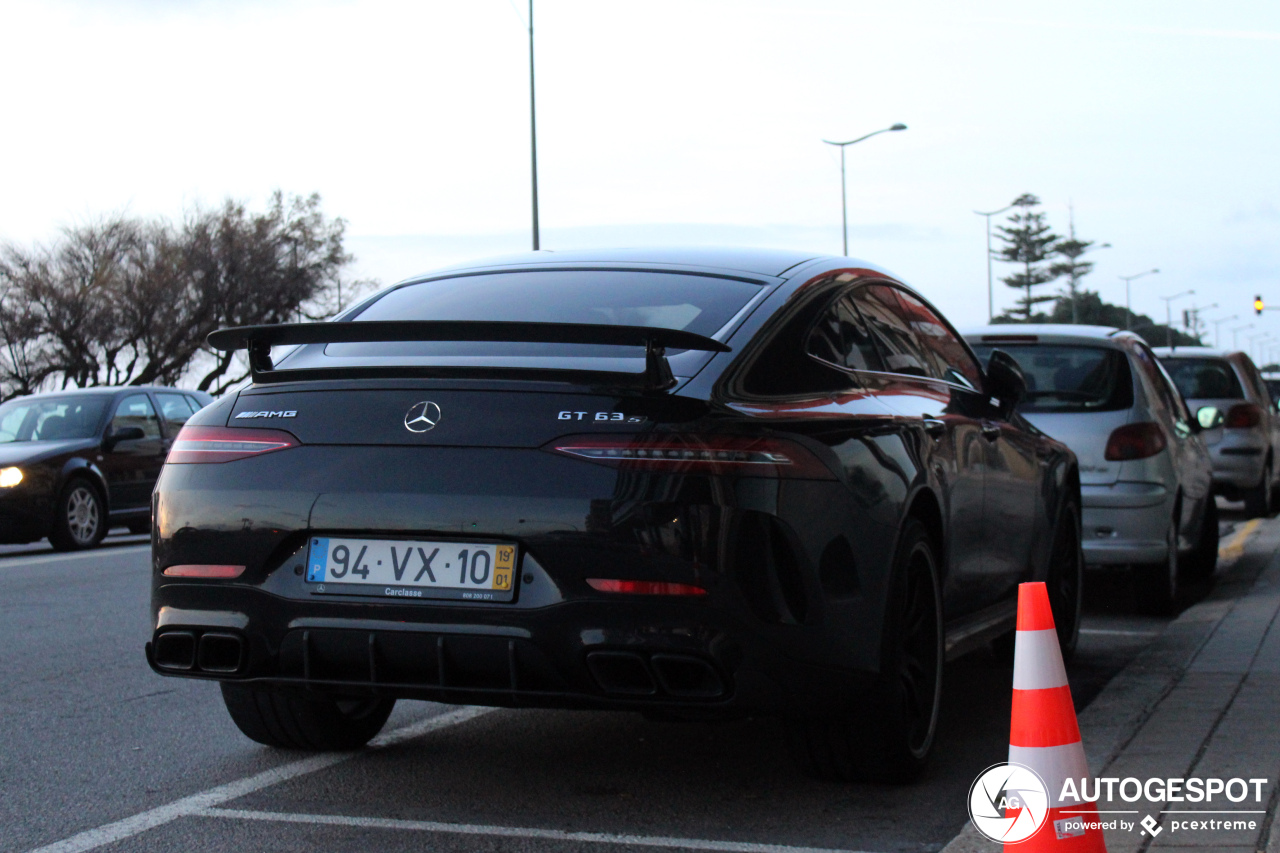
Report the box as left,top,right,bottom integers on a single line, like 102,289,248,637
1080,483,1174,566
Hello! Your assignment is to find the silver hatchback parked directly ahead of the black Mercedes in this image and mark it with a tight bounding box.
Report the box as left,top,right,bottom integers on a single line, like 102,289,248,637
965,325,1221,612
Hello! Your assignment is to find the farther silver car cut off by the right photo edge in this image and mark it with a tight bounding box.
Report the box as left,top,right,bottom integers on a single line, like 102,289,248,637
1155,347,1280,516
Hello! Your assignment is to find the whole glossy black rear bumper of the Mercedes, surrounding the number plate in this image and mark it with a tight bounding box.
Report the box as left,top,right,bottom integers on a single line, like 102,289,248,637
148,447,896,713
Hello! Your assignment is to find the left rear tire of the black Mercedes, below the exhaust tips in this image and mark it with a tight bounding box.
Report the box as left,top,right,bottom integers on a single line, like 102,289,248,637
221,681,396,752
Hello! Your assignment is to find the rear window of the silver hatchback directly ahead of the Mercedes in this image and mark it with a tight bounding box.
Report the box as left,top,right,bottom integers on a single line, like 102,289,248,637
973,343,1133,412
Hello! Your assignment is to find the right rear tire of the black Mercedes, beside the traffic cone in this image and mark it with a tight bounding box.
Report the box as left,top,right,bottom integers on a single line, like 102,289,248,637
791,519,943,783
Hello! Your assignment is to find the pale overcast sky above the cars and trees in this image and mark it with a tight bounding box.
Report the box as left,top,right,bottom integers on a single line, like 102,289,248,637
0,0,1280,343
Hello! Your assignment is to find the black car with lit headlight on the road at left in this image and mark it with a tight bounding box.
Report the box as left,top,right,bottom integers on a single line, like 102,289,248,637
0,386,212,551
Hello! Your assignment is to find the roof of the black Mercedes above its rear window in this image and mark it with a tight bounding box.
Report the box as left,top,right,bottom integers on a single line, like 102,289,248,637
404,246,829,283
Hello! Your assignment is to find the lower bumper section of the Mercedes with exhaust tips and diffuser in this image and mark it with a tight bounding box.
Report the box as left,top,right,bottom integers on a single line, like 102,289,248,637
147,573,870,716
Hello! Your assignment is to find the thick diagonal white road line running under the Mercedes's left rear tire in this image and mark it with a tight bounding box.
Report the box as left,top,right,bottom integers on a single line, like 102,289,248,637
31,707,497,853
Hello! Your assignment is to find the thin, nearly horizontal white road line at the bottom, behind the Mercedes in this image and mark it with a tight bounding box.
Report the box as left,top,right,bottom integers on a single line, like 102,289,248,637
197,808,858,853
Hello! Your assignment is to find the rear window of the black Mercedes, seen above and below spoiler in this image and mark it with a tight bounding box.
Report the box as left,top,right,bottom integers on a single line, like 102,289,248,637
325,270,762,359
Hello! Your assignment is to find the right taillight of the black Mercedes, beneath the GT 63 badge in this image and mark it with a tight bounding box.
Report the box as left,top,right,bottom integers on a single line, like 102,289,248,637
547,434,836,480
